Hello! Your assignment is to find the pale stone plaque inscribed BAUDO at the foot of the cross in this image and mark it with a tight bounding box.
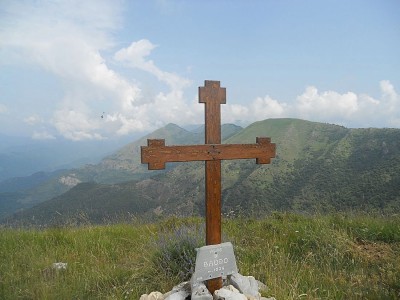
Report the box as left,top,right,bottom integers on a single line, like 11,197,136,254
192,242,238,282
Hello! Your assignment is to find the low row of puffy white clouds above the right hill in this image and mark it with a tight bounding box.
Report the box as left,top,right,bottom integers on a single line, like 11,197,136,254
223,80,400,127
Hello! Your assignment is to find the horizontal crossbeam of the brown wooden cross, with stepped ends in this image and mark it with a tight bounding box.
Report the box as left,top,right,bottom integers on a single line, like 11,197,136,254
141,137,275,170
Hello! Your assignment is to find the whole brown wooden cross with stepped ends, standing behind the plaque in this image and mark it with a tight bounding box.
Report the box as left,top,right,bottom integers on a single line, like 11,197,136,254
141,80,275,293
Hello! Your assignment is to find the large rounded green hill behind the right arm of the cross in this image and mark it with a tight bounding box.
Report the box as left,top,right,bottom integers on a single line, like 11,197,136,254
224,119,400,212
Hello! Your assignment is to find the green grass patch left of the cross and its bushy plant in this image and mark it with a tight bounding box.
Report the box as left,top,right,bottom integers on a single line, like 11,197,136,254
0,221,153,299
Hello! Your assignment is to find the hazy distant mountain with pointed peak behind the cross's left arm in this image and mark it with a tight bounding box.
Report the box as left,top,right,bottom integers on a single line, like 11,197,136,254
0,124,242,218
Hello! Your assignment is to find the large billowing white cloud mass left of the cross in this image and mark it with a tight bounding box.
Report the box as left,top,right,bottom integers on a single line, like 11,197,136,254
0,1,193,140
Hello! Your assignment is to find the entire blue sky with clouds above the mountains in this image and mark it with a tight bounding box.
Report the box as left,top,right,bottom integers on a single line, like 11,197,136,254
0,0,400,141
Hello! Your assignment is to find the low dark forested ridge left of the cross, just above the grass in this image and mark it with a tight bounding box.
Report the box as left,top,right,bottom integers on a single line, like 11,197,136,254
7,182,157,225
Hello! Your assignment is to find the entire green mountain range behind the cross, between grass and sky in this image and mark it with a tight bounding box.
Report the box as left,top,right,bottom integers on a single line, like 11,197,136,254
0,119,400,225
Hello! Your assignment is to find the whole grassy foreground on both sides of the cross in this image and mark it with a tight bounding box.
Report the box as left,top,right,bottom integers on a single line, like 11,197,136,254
0,213,400,300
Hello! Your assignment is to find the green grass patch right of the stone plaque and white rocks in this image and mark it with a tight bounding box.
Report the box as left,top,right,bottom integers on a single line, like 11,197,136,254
225,214,400,299
